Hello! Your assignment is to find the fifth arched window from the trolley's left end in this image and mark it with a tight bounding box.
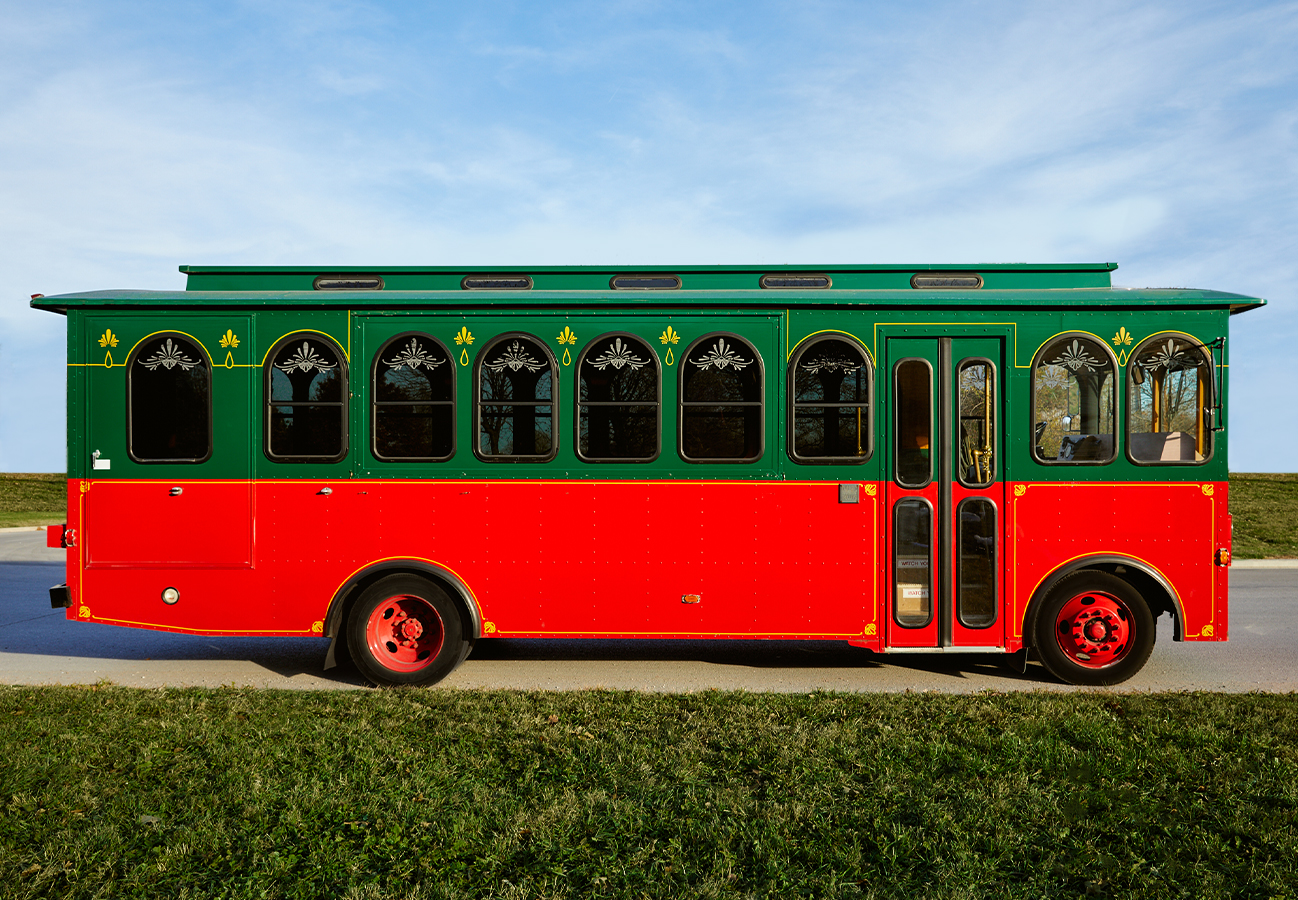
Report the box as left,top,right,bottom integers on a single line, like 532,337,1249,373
578,335,659,461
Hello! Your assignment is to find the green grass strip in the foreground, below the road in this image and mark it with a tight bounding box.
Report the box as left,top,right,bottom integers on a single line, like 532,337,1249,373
0,687,1298,899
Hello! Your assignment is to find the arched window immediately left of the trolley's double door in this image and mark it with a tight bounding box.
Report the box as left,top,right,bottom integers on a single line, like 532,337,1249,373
789,338,870,462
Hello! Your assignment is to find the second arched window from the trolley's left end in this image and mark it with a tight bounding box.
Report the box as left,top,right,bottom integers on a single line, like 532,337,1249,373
265,331,348,462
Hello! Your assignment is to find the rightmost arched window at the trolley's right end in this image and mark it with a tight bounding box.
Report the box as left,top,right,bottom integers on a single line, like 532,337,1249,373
1127,334,1215,464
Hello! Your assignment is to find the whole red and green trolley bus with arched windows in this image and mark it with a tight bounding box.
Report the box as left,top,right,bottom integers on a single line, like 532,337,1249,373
32,264,1264,684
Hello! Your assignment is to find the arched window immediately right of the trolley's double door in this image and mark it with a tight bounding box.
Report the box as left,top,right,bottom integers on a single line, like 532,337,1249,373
1032,335,1116,462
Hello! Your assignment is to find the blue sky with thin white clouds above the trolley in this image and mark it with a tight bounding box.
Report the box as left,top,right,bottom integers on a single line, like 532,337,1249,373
0,0,1298,471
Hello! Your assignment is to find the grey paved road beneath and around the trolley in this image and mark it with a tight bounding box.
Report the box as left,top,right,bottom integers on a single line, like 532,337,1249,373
0,531,1298,694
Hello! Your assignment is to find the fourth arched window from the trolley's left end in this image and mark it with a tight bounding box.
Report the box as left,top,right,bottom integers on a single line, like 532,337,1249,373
474,334,558,462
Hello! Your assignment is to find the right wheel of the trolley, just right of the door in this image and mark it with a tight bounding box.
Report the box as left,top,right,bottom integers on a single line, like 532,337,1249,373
1033,571,1155,684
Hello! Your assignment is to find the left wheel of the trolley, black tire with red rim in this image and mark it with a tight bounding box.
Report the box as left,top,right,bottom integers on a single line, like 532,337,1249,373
347,574,472,684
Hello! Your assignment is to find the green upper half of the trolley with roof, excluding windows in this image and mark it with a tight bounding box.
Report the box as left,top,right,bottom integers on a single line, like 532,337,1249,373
32,264,1266,481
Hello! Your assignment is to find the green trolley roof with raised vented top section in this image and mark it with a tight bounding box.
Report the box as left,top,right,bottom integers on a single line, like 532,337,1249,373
31,262,1266,313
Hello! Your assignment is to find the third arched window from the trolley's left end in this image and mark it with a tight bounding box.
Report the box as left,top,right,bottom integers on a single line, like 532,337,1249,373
374,334,456,461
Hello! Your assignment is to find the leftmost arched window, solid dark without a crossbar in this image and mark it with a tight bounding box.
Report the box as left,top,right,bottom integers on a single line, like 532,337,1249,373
126,332,212,462
